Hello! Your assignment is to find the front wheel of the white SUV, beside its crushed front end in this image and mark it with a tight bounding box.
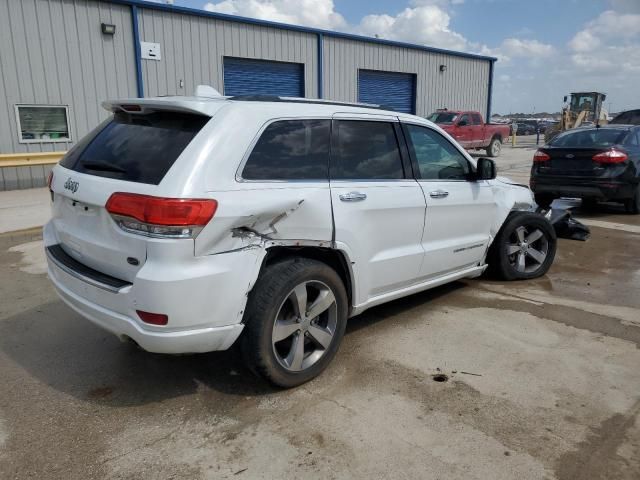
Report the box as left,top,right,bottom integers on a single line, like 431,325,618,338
488,212,557,280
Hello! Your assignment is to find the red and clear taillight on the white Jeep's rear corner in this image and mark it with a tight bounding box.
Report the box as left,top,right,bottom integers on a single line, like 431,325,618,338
105,192,218,238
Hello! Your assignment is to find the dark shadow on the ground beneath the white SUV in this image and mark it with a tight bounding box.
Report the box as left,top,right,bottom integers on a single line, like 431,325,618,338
0,282,465,407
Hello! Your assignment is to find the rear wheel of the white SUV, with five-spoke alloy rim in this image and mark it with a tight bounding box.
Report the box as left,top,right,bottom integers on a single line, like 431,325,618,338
241,258,348,388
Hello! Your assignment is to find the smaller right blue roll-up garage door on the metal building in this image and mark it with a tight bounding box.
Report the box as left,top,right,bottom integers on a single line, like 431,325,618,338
358,70,416,113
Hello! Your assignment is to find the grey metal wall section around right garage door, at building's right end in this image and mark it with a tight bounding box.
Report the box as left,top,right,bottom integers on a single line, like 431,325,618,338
323,35,490,116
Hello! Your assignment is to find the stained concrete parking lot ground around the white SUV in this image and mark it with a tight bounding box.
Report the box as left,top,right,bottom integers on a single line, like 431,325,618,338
0,139,640,480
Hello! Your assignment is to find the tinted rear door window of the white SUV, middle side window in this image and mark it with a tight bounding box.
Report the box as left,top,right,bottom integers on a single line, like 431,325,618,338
331,120,404,180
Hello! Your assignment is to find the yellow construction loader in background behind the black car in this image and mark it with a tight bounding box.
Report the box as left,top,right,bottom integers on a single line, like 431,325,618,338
544,92,607,142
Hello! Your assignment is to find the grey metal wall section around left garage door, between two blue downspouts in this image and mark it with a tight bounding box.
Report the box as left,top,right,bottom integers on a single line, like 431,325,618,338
138,8,318,98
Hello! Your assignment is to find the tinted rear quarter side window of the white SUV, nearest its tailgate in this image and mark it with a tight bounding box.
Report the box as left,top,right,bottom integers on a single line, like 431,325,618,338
242,120,331,181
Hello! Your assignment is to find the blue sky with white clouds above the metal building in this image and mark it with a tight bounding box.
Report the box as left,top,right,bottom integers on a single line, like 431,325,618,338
152,0,640,114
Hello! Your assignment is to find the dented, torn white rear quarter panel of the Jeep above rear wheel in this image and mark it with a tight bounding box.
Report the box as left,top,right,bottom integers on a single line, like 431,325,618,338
195,108,333,255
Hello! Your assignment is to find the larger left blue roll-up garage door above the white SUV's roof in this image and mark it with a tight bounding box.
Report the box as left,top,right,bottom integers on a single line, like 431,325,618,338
224,57,304,97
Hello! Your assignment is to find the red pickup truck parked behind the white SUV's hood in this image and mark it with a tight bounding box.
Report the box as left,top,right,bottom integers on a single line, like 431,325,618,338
427,110,511,157
